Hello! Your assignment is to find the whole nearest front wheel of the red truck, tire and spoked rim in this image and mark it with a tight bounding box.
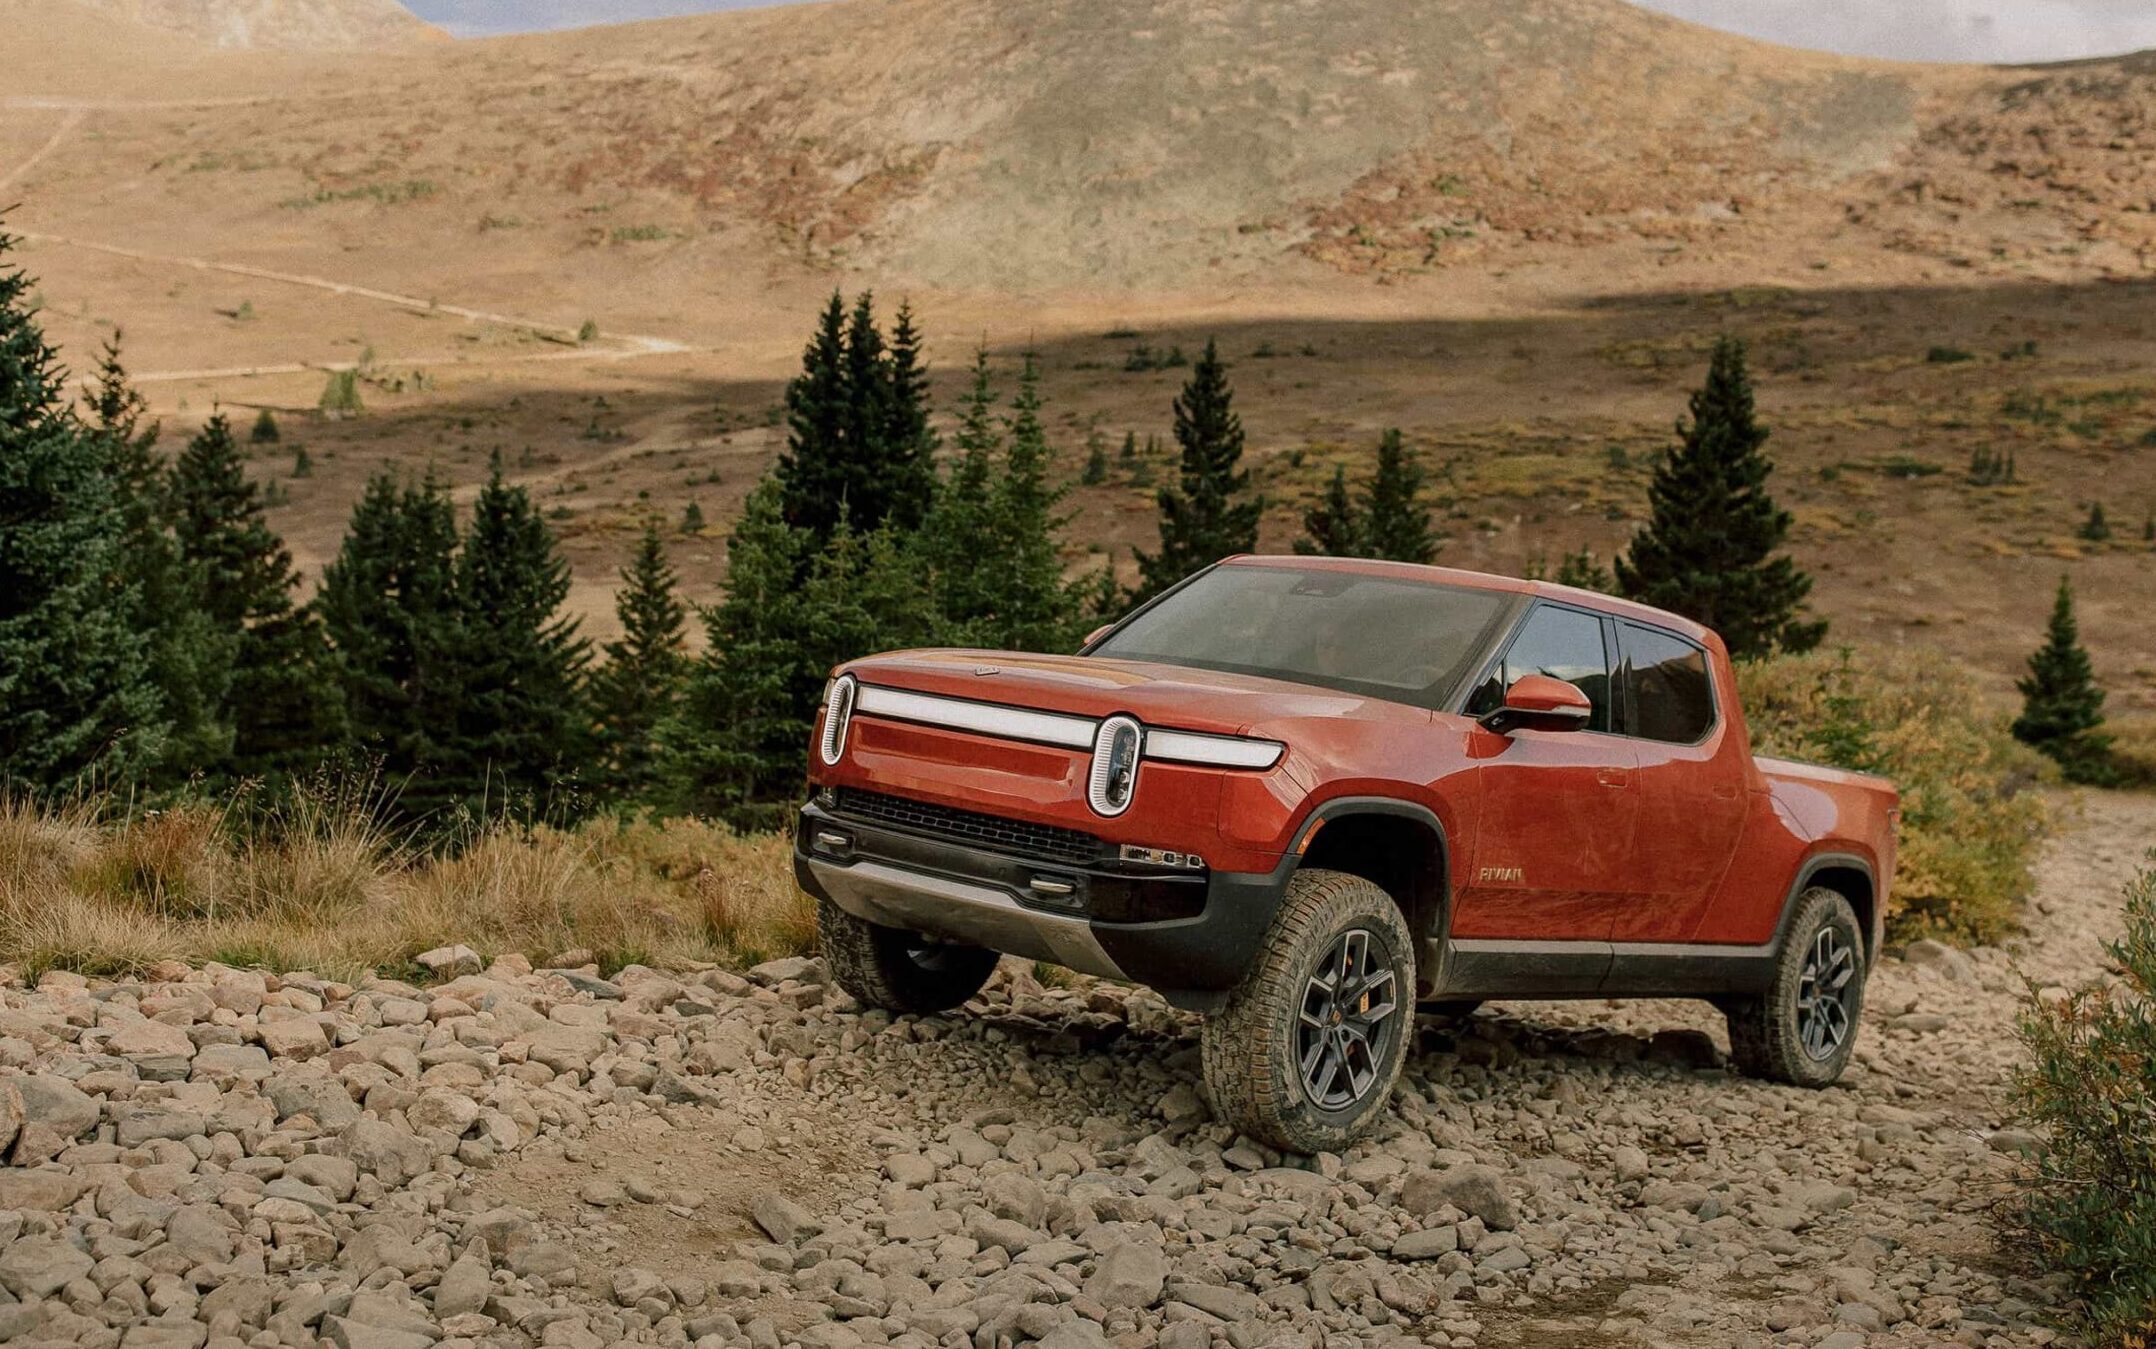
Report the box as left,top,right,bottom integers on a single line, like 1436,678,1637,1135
1203,871,1414,1153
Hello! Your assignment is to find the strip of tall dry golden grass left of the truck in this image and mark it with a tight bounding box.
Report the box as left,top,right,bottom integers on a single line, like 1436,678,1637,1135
0,775,815,978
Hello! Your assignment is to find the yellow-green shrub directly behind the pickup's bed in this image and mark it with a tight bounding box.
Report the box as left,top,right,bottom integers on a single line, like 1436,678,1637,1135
1738,651,2053,942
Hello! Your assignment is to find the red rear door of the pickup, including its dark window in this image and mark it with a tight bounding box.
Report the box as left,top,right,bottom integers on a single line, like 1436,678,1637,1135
1611,623,1749,942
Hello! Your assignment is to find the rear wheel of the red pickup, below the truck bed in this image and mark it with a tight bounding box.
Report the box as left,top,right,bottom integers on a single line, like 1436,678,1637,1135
1723,886,1865,1088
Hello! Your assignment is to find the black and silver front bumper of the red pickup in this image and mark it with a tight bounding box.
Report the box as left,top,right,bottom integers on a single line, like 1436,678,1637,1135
793,804,1296,991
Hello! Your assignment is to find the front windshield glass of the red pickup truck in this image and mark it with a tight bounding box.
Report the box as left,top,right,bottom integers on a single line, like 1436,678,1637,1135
1089,567,1514,709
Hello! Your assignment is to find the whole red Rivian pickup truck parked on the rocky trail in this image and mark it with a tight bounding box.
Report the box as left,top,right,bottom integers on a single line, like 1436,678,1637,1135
796,558,1897,1153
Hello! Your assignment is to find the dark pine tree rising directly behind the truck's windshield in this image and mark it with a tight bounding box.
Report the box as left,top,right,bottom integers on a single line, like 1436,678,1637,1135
1138,340,1266,599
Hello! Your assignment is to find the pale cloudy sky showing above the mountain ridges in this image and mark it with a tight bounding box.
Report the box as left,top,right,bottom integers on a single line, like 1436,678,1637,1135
405,0,2156,60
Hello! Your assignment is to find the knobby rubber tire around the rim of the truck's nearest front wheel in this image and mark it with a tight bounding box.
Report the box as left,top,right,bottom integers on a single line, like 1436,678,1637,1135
1203,871,1414,1155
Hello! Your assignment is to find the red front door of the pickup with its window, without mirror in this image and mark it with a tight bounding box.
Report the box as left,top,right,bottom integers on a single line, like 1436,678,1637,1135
1453,601,1639,952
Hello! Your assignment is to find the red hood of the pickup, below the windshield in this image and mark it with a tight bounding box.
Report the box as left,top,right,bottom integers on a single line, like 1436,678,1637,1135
841,649,1429,735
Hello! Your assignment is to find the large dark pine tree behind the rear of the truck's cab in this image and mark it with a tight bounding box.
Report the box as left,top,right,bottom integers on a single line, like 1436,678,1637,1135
1617,338,1826,657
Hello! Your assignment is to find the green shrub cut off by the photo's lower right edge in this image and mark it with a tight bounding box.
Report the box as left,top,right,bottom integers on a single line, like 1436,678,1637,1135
2018,871,2156,1347
